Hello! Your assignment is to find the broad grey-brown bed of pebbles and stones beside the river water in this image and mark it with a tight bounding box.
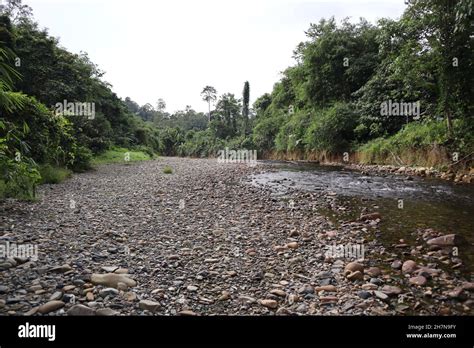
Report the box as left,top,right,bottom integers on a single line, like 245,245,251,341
0,158,474,316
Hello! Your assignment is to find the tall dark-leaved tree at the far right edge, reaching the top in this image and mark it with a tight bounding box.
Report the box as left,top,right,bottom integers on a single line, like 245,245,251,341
402,0,474,135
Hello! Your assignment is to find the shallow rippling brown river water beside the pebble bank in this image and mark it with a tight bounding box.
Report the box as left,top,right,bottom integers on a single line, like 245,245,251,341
252,161,474,276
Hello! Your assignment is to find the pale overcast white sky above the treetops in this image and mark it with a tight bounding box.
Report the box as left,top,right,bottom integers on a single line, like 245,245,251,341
23,0,406,112
